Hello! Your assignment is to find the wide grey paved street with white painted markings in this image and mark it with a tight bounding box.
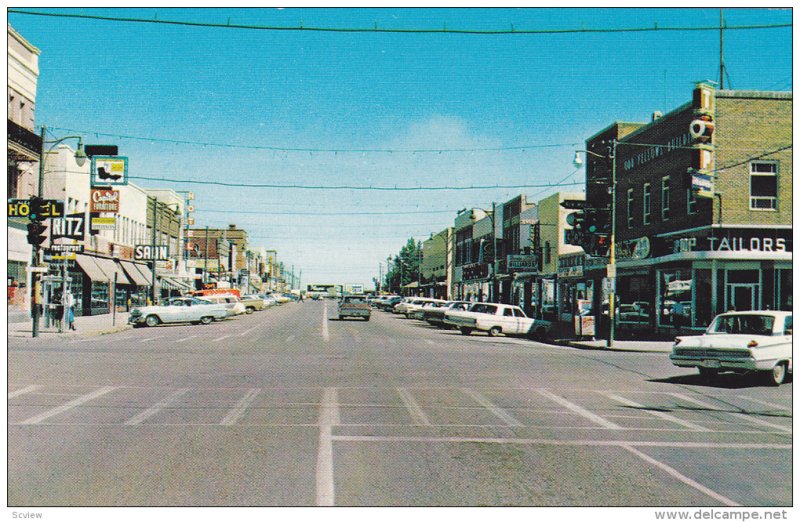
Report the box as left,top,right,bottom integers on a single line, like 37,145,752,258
8,301,792,506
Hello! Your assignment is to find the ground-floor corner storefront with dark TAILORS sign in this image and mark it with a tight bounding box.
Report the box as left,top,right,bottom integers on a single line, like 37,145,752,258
616,227,792,333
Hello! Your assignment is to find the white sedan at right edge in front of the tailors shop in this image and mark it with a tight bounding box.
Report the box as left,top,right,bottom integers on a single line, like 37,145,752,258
669,310,792,386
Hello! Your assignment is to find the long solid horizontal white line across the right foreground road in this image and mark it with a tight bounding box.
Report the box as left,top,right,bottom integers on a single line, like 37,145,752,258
333,435,793,450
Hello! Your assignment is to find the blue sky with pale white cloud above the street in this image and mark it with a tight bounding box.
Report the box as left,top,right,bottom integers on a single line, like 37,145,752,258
8,8,792,286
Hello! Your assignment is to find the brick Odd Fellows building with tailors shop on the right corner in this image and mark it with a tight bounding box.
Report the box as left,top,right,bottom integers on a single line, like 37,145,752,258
584,84,792,333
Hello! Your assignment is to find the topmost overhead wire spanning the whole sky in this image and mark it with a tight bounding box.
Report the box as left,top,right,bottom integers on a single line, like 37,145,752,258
8,9,792,36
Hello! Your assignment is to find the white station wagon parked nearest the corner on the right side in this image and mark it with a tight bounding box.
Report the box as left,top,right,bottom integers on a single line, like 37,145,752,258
444,303,552,339
